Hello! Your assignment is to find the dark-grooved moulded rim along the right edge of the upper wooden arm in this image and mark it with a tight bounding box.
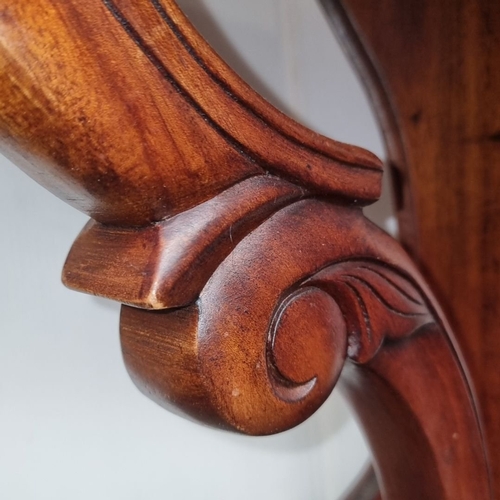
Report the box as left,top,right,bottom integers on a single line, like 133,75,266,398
102,0,381,204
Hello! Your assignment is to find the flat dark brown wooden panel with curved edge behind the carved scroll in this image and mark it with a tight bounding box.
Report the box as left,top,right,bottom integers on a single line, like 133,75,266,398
322,0,500,498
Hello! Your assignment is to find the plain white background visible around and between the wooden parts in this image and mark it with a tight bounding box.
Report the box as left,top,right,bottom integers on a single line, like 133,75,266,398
0,0,389,500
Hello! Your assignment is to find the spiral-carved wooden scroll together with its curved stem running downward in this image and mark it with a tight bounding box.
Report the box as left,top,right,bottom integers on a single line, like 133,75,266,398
121,199,490,499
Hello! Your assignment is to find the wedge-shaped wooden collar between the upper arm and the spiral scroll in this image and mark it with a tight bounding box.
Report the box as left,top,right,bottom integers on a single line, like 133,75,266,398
63,175,305,309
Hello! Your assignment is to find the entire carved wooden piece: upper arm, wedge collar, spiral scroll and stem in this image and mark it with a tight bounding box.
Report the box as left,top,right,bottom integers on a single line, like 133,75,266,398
0,0,491,500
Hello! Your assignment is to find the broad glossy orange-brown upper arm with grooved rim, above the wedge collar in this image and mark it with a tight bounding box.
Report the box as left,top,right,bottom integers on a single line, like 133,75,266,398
0,0,381,226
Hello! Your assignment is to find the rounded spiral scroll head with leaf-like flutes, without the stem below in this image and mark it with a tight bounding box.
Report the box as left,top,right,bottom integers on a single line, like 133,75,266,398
122,199,434,434
